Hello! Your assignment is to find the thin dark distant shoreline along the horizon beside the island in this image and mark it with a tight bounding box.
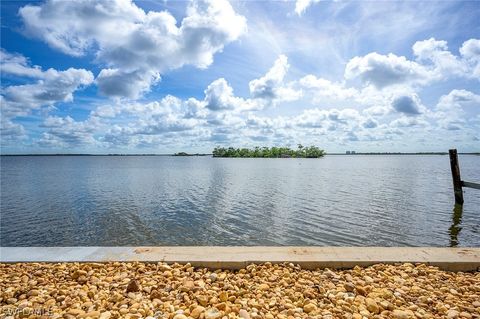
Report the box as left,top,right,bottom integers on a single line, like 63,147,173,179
0,152,480,158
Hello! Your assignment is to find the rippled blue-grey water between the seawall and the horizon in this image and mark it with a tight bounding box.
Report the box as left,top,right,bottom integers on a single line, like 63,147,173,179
0,155,480,246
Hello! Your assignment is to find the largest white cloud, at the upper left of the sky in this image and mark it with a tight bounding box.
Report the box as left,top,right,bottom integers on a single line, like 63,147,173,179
19,0,246,98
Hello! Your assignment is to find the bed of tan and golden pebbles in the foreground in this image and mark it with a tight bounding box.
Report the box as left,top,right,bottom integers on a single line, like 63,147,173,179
0,262,480,319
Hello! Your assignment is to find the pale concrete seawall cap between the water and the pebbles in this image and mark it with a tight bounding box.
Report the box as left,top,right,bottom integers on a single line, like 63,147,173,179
0,246,480,271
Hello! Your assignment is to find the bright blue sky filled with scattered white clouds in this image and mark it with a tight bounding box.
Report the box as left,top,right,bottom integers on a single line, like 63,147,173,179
0,0,480,154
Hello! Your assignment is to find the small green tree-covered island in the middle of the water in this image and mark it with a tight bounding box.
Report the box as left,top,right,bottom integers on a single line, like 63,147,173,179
213,144,325,158
